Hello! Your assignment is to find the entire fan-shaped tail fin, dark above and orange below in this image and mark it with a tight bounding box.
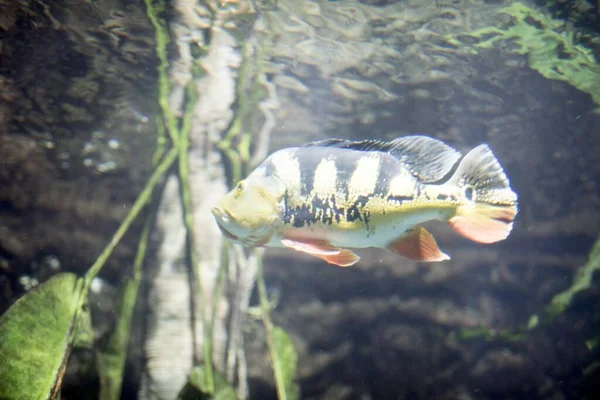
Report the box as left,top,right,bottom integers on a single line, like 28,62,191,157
448,144,518,243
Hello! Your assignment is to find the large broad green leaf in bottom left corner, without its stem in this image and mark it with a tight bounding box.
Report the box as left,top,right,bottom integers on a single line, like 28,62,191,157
0,273,84,399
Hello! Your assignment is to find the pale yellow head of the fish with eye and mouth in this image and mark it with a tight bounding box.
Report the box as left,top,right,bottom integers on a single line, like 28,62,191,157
211,168,285,247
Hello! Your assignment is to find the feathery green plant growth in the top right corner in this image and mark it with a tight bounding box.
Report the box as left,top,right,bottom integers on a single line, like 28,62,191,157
458,2,600,113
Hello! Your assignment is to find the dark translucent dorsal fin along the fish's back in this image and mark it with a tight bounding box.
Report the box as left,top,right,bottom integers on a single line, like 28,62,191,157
303,135,461,182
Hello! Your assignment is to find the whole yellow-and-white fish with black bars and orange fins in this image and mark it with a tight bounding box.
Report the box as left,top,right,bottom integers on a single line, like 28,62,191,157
211,135,518,267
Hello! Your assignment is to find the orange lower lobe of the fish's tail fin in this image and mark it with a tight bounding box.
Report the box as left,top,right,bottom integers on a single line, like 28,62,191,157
448,203,517,243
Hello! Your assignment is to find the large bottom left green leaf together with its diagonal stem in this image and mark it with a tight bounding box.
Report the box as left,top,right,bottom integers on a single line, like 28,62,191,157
0,143,177,398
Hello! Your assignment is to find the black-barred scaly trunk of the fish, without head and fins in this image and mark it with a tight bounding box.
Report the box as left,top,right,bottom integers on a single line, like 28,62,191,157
262,147,452,248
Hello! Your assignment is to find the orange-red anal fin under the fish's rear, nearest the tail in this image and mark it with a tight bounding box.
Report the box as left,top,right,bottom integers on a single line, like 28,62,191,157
387,226,450,262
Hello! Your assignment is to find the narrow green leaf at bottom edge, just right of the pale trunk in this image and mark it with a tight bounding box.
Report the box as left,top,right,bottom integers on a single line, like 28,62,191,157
271,326,300,400
